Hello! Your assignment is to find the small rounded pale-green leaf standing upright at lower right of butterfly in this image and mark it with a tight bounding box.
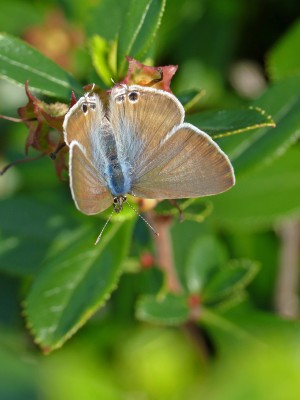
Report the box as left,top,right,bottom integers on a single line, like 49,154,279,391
185,235,228,293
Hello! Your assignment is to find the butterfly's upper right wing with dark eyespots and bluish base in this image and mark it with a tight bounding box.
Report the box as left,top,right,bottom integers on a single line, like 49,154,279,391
110,85,184,173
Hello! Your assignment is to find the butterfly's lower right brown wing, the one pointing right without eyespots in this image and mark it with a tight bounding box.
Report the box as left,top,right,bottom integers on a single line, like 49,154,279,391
132,124,234,199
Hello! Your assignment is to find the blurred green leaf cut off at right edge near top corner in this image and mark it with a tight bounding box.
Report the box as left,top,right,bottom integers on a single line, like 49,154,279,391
267,20,300,80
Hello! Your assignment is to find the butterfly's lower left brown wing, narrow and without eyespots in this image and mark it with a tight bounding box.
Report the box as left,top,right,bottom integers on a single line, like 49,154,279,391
69,141,113,215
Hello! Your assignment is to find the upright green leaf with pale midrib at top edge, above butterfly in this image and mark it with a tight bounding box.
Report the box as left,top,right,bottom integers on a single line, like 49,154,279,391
117,0,166,76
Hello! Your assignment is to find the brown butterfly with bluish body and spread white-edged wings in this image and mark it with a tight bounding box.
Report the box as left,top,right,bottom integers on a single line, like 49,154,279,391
63,84,235,227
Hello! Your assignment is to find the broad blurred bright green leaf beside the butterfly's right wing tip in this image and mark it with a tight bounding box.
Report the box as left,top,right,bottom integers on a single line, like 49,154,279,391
210,145,300,230
